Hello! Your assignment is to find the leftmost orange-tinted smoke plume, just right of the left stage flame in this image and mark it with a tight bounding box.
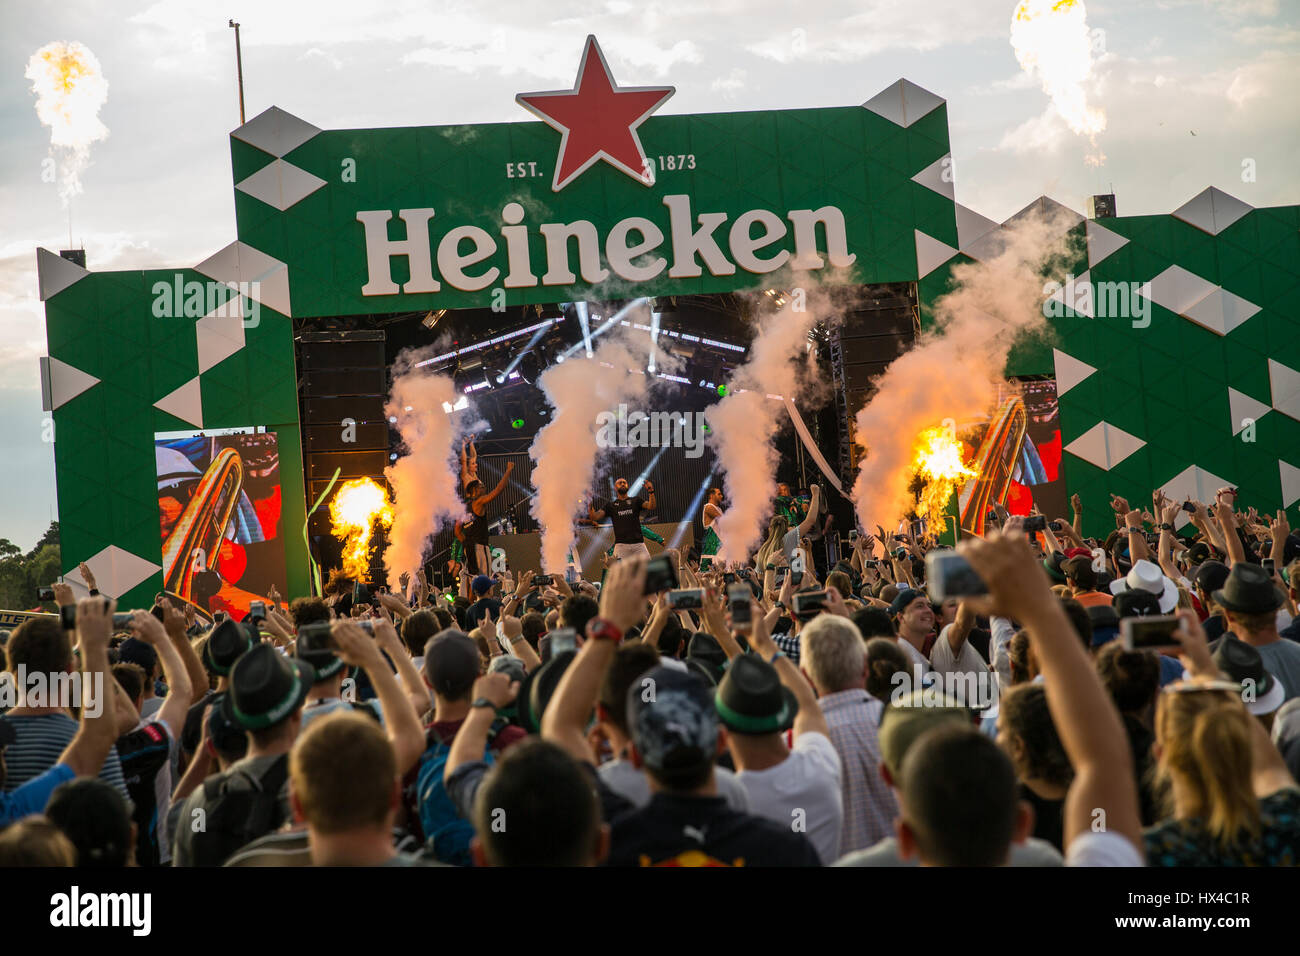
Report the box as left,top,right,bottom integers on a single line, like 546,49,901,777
384,349,473,581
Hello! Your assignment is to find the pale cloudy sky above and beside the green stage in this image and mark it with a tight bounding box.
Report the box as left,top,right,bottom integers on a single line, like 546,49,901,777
0,0,1300,549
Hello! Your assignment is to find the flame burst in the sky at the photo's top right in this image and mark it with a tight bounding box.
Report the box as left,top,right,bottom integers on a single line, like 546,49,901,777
1011,0,1106,165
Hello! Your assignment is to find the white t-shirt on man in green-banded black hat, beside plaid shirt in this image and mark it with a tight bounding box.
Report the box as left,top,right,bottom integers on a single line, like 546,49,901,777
736,732,844,866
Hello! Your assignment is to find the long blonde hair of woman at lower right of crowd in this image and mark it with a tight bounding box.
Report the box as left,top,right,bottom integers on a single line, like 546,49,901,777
1156,689,1260,847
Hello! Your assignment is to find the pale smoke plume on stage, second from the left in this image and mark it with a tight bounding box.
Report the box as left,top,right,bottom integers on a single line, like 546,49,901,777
528,332,649,574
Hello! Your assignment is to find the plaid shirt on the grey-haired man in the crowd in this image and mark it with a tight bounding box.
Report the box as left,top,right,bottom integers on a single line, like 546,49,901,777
816,691,898,856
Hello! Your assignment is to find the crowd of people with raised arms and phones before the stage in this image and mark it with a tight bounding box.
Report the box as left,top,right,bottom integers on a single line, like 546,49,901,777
0,478,1300,868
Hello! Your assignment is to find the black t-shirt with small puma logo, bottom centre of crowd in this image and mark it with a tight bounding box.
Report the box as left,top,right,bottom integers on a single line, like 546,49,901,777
606,793,820,866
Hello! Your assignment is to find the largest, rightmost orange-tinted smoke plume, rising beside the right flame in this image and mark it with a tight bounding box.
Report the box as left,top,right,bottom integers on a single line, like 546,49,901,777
853,209,1070,531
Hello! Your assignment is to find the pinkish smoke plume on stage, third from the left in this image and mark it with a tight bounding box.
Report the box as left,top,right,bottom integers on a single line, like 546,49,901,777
705,295,827,562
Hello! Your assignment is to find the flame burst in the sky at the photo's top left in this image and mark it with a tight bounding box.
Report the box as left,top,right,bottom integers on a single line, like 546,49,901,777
23,40,108,204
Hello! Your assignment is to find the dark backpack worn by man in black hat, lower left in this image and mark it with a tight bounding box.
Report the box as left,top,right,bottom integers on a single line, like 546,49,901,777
191,756,289,866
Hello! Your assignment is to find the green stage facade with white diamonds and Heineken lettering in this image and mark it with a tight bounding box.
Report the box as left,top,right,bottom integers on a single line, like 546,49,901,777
38,59,1300,605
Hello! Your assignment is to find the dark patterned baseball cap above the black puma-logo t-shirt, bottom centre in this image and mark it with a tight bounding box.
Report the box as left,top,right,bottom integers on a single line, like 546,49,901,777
627,665,718,786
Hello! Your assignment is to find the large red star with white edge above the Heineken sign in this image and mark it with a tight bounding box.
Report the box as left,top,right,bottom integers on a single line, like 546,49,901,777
515,36,676,193
